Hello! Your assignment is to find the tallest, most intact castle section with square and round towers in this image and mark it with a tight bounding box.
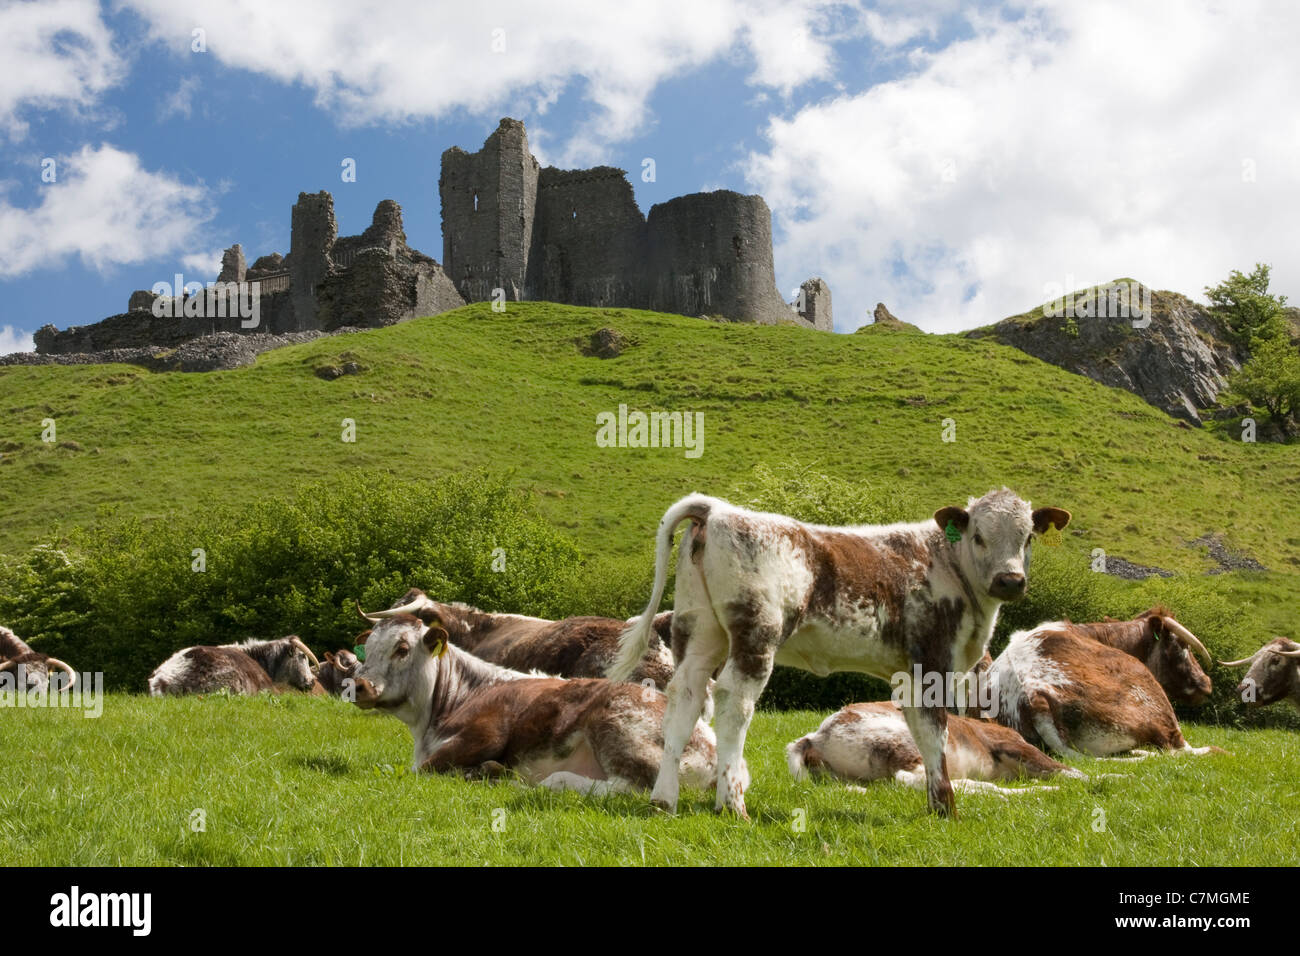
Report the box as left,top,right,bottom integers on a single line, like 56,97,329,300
438,118,832,330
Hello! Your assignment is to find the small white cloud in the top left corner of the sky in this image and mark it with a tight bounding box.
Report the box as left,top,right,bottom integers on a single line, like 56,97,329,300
0,0,126,139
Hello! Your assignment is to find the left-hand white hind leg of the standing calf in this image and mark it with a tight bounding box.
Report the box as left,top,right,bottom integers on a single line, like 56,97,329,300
650,608,727,813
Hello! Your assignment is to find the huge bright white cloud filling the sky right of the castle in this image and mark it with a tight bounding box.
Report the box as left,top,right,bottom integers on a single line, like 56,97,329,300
746,0,1300,332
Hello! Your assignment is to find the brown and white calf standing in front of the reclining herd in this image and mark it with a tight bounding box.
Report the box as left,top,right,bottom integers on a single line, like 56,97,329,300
610,488,1070,819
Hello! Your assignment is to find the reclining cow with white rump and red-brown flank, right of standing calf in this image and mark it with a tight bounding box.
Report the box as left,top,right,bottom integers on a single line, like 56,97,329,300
982,620,1218,757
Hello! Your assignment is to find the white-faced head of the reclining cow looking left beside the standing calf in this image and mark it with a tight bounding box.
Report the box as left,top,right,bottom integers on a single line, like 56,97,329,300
352,607,447,717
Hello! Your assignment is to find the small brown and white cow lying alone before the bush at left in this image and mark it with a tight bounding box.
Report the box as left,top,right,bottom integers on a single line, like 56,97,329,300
150,635,320,697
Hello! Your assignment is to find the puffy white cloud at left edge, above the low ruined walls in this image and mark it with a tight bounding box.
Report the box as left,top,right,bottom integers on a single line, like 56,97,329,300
0,144,213,278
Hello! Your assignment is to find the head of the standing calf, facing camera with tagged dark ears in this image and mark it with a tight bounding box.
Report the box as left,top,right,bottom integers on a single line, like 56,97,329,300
935,488,1070,601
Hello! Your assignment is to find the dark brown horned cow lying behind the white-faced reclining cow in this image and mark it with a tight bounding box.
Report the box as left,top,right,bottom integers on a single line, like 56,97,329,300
377,588,672,691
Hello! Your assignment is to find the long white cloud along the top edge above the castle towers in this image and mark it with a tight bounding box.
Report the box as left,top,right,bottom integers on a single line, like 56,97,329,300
125,0,854,164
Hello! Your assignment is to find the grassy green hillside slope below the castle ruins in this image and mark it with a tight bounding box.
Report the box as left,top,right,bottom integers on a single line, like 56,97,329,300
0,303,1300,572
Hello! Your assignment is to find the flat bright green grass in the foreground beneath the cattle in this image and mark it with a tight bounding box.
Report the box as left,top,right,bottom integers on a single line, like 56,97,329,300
0,695,1300,866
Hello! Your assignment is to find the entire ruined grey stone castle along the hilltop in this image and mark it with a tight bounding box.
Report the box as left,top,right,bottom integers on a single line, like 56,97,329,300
20,118,833,368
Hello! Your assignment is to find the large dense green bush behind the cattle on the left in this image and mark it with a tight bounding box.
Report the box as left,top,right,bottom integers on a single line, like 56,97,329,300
0,472,585,691
